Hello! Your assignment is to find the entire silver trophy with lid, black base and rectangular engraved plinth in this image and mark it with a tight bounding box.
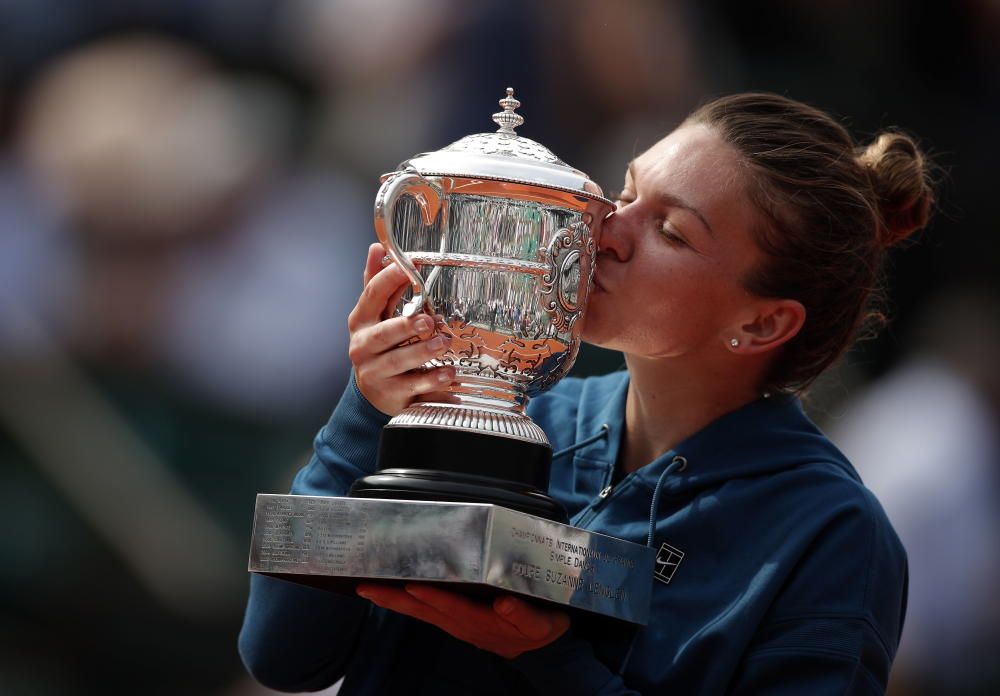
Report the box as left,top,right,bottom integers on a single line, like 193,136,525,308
250,88,653,623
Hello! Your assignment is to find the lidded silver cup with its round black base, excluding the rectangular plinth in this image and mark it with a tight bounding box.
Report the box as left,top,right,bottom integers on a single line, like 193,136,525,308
351,89,614,521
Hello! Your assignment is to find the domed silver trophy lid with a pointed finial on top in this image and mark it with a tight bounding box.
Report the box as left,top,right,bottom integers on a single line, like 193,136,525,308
399,87,614,207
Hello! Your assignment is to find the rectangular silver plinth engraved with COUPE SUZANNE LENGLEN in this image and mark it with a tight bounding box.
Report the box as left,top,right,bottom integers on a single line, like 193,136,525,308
249,494,654,625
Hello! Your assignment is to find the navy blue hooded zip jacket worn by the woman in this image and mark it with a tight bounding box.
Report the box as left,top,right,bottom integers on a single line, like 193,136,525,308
239,372,906,696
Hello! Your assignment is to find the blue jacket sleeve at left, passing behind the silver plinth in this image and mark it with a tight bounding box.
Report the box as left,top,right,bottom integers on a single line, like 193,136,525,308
239,376,389,691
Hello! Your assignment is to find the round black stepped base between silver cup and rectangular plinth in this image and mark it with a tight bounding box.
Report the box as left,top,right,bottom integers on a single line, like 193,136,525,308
348,426,569,524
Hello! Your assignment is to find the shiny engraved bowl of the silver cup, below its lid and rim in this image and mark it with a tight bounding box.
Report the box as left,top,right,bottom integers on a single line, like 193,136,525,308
395,196,593,396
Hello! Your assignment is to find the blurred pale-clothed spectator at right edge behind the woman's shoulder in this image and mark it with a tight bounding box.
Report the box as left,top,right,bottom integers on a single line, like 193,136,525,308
828,291,1000,694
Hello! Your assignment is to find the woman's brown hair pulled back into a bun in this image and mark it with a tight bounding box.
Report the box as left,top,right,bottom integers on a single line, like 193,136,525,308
686,93,934,392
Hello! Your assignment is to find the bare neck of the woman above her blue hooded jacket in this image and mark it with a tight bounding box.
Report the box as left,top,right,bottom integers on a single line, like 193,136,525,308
620,356,760,472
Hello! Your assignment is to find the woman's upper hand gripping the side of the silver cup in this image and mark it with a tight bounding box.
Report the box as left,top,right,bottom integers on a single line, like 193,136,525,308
347,243,455,416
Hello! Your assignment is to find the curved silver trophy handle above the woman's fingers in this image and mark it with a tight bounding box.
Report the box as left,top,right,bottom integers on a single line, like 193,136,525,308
375,170,441,317
